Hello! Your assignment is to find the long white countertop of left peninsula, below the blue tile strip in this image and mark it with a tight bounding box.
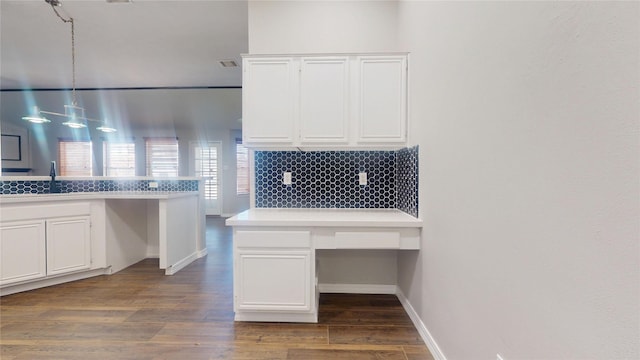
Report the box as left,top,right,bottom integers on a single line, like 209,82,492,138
0,191,200,204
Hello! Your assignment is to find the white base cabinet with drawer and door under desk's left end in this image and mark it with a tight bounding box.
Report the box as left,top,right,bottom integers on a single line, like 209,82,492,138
234,231,318,322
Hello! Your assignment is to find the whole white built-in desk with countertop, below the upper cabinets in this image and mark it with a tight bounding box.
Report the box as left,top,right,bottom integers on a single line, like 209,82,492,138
226,208,422,322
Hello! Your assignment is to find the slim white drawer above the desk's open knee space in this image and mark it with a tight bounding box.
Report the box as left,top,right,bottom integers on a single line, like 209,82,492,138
335,231,400,249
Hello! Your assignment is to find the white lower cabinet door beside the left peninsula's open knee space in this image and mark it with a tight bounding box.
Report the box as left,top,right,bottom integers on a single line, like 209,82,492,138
47,216,91,275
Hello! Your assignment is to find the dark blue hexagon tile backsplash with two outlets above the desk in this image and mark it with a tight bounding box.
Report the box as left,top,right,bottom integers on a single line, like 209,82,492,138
255,146,418,217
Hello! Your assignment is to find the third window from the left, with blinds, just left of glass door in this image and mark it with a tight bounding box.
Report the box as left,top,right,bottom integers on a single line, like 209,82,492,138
145,138,178,177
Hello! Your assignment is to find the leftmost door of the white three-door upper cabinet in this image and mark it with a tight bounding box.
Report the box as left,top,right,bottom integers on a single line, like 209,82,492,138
242,58,298,145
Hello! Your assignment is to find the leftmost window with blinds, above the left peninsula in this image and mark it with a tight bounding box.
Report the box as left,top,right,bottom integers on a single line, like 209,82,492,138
58,139,93,176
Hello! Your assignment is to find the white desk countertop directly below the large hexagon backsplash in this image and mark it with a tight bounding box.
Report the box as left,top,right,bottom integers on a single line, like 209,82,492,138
226,208,422,228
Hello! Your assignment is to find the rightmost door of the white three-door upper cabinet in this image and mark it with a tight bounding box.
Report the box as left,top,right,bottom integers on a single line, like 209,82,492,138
356,56,407,143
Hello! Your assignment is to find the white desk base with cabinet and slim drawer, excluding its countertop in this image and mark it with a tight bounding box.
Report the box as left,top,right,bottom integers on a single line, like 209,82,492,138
227,222,420,322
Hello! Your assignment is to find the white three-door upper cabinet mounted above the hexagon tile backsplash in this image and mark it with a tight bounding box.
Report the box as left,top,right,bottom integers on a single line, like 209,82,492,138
242,54,407,149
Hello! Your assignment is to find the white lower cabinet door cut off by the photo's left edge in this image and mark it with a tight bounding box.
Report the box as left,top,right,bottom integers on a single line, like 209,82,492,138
0,220,46,285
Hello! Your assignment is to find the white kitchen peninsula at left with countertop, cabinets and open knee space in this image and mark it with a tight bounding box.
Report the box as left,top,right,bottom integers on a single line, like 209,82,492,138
0,191,206,295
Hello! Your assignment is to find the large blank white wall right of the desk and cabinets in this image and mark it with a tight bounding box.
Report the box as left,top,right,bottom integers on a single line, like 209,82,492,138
398,1,640,360
